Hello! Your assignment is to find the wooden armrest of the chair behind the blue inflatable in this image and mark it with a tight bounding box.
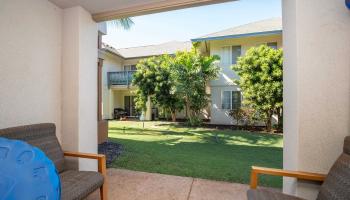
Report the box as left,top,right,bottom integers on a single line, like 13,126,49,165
63,151,107,178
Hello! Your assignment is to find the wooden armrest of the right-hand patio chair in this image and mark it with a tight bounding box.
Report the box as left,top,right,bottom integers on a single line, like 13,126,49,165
250,166,326,189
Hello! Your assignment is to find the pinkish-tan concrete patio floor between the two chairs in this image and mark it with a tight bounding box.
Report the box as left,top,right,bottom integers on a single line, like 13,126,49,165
88,169,249,200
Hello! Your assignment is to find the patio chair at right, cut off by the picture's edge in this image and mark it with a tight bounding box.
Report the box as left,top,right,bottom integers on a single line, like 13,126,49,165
247,136,350,200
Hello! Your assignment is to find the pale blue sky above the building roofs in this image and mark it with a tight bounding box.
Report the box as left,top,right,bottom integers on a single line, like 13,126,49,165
103,0,282,48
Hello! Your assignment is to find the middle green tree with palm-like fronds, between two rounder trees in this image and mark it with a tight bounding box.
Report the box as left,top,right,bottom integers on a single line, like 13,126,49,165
171,48,220,125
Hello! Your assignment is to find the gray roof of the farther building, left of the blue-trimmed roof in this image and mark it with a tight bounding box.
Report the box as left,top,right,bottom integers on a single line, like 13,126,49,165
114,41,192,59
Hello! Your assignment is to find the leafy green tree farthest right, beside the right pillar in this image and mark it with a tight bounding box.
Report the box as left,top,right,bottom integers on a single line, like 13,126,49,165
232,45,283,131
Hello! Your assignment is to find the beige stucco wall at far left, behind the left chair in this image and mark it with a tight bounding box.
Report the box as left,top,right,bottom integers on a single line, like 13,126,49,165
0,0,62,140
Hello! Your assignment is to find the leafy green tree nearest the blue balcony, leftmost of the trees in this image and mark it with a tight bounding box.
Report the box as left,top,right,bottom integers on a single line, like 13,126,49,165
133,55,183,121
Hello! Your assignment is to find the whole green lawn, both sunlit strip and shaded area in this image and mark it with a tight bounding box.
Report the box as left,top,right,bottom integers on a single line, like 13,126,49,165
109,121,283,187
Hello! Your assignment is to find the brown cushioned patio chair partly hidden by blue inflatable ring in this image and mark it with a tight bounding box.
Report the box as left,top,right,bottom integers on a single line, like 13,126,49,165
0,123,107,200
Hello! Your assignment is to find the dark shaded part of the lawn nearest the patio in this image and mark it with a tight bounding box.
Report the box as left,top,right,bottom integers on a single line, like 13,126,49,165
110,138,283,187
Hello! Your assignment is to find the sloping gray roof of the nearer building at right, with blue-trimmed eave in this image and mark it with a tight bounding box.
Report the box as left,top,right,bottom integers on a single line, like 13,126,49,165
192,18,282,42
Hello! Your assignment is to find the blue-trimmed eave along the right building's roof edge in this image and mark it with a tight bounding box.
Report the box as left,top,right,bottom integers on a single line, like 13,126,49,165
191,30,282,42
